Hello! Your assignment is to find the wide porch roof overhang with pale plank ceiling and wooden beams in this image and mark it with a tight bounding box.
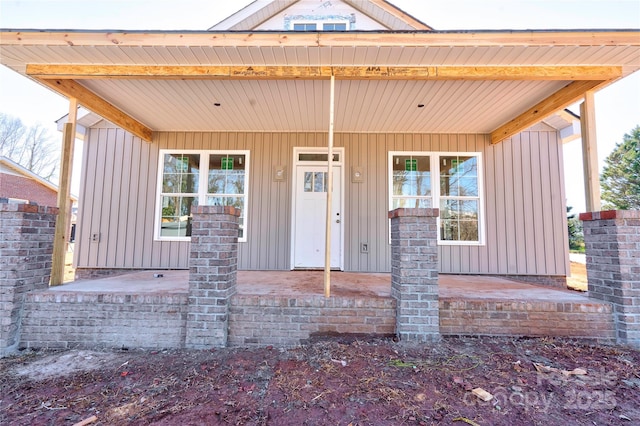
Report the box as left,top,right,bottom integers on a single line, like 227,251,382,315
0,30,640,143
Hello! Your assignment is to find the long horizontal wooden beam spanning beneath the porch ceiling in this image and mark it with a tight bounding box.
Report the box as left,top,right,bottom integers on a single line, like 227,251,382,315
27,64,622,81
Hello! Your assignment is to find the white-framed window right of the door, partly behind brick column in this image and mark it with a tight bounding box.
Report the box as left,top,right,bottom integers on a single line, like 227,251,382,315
389,152,483,245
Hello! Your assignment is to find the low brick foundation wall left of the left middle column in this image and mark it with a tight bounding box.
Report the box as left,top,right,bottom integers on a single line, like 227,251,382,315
20,290,187,349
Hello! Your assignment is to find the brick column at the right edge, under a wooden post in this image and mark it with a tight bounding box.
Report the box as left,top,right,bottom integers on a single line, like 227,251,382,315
580,210,640,348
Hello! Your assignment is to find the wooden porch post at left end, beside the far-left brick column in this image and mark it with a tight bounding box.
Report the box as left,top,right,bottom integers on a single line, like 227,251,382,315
51,98,78,285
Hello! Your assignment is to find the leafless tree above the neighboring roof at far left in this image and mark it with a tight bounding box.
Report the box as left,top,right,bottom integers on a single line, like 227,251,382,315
0,113,60,180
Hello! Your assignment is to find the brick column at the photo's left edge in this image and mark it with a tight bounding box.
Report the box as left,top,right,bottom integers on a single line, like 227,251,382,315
0,199,58,357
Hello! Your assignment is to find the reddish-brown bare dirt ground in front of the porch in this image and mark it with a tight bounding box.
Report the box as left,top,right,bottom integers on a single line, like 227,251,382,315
0,337,640,426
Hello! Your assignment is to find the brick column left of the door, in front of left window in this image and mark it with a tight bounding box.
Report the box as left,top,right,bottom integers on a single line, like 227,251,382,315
186,206,240,349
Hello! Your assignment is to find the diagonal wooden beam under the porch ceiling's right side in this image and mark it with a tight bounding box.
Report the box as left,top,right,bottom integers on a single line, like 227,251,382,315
491,80,609,144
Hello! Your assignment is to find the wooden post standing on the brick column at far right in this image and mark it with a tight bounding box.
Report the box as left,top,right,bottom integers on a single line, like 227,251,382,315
580,91,601,212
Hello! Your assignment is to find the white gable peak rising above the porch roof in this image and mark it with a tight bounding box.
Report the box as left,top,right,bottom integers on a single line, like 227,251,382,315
209,0,431,31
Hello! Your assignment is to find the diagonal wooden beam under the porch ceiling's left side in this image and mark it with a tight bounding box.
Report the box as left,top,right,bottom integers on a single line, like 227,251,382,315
37,78,152,142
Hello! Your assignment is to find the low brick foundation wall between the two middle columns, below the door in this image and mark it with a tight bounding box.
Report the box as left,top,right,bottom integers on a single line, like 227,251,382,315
229,295,396,346
